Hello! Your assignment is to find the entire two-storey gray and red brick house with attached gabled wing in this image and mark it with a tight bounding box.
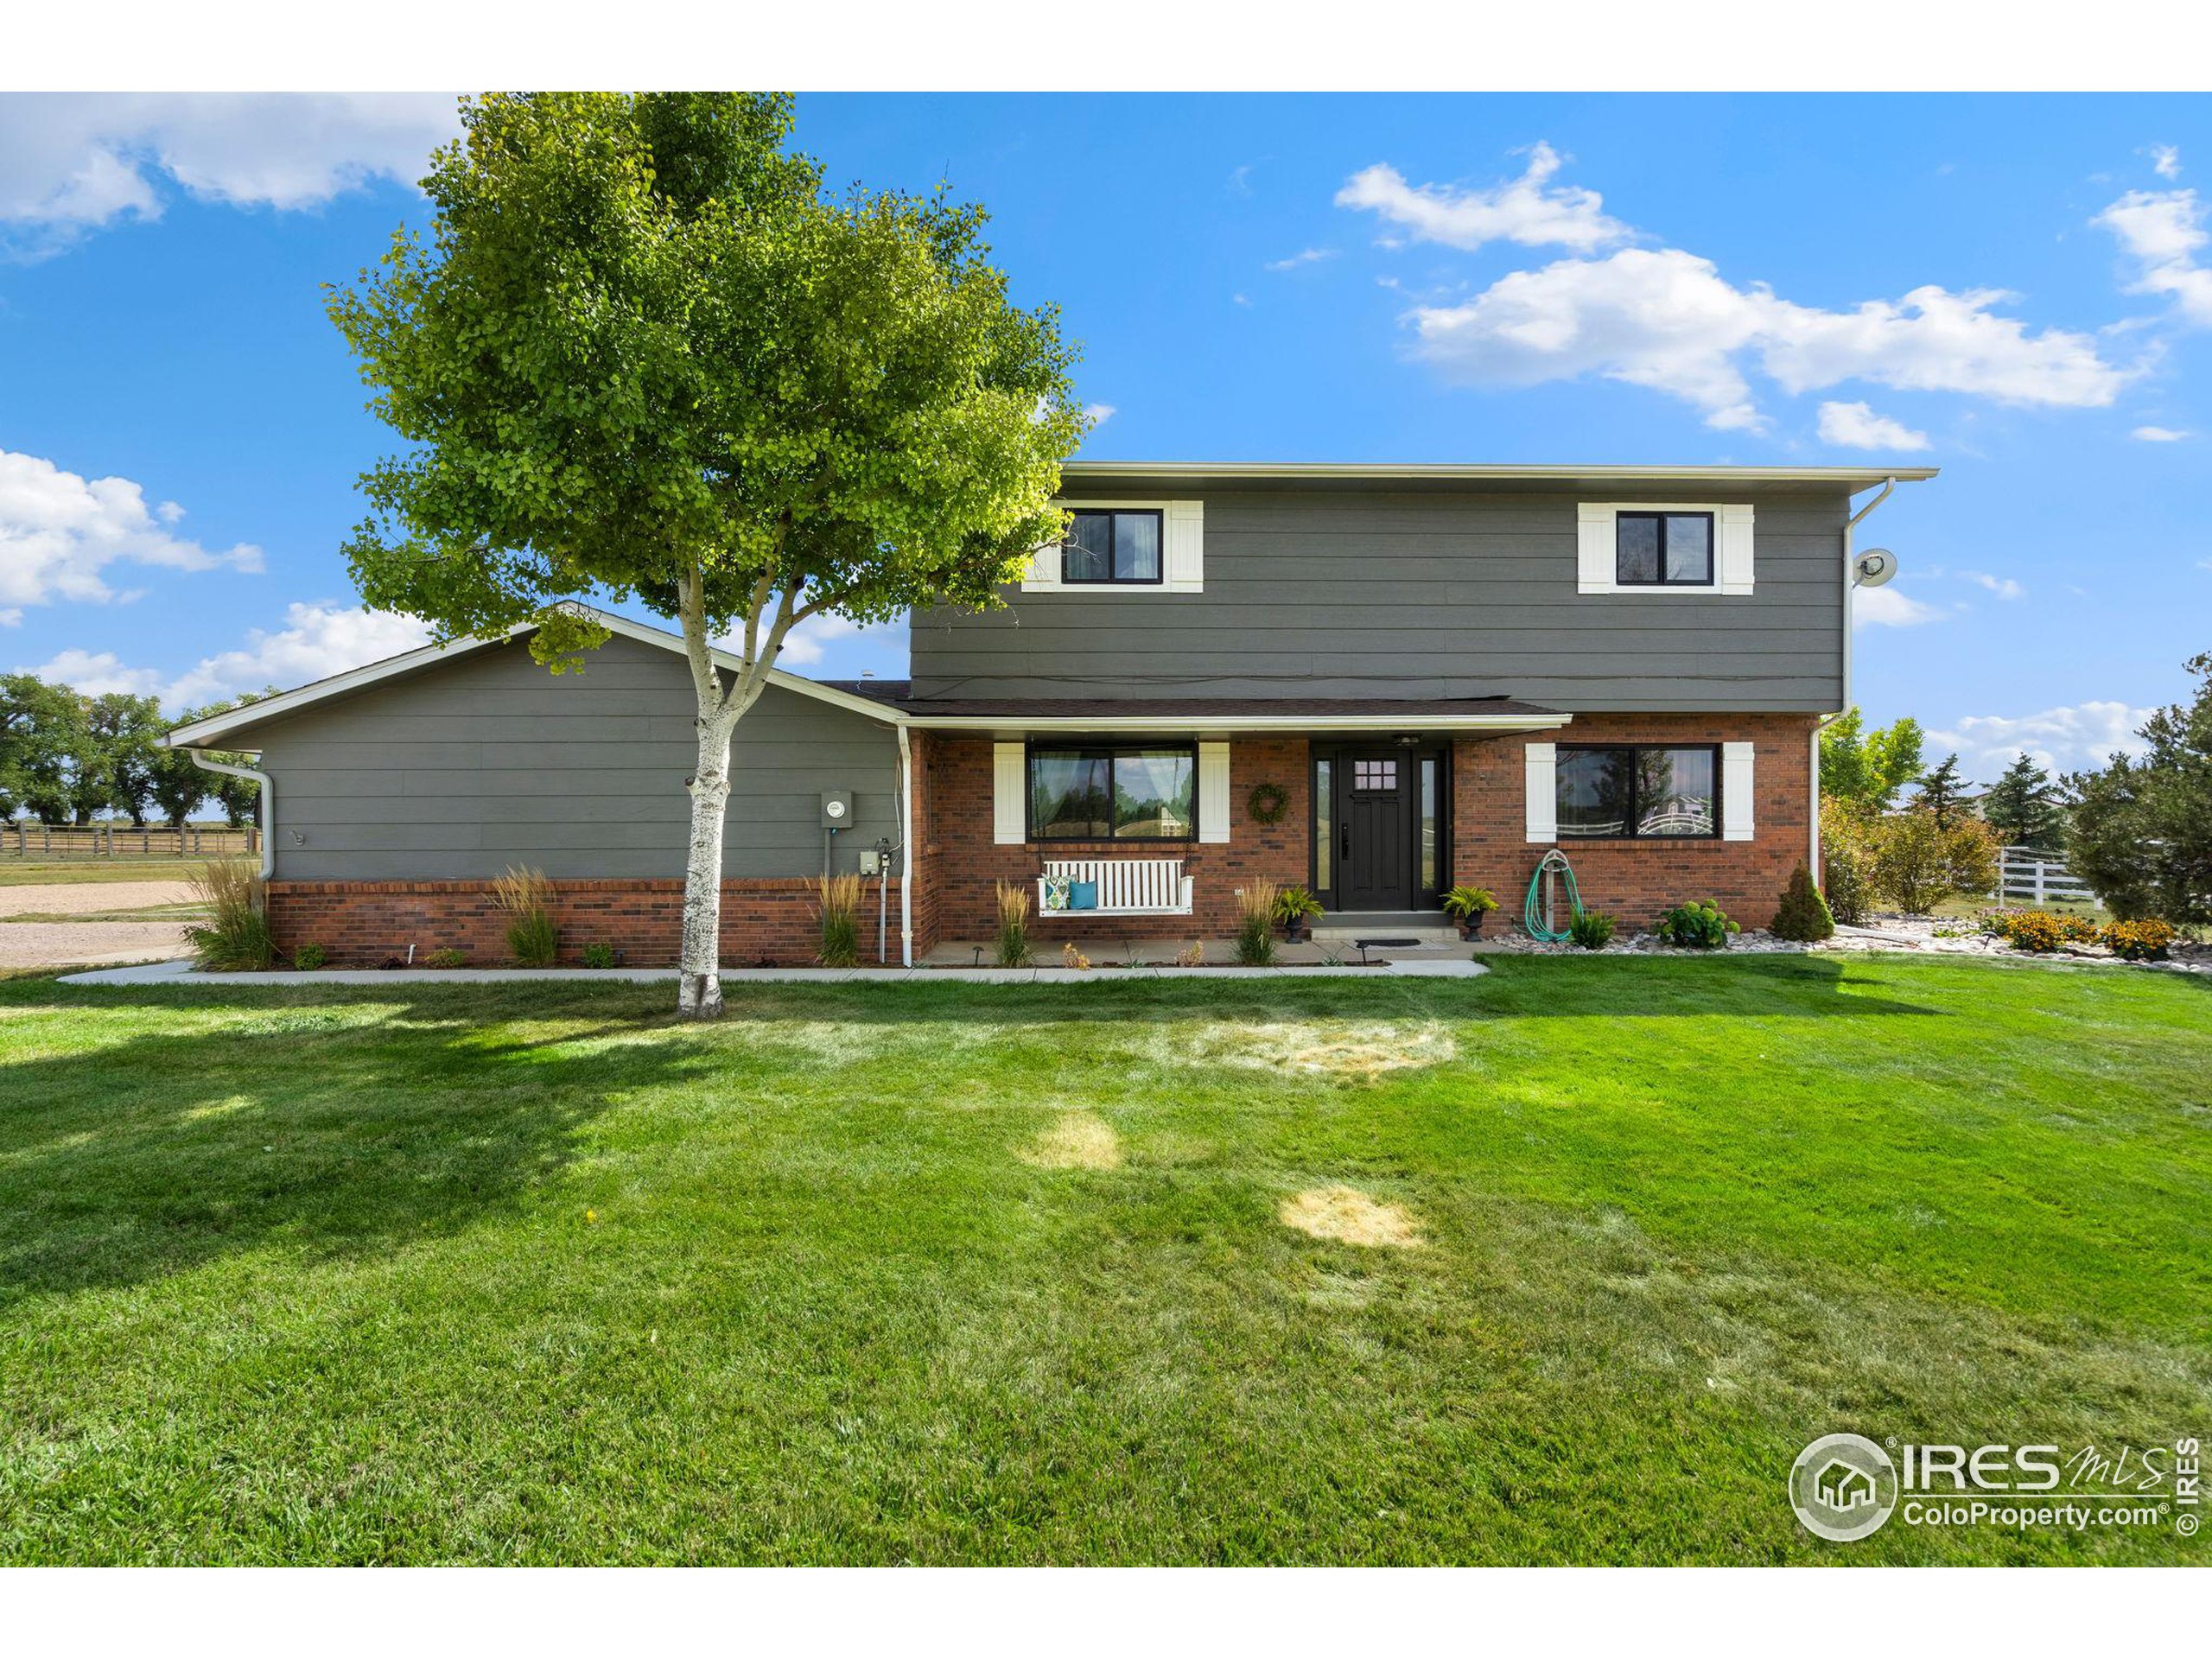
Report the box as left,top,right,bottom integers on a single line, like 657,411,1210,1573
170,462,1933,964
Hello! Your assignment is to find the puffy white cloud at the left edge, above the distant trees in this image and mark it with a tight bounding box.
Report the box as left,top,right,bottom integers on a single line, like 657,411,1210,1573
0,449,261,613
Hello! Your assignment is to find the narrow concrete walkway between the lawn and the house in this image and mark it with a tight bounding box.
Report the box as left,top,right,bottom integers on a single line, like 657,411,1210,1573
60,957,1489,984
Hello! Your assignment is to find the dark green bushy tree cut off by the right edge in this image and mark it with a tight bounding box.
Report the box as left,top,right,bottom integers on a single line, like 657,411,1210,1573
2066,652,2212,927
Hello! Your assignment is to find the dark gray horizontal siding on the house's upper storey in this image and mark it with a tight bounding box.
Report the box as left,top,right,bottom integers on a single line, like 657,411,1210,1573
912,480,1849,712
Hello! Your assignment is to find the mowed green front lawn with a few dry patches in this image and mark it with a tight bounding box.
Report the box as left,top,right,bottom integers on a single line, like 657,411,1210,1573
0,957,2212,1561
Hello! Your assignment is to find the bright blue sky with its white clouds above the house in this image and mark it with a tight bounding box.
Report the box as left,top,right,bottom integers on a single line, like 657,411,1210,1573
0,95,2212,777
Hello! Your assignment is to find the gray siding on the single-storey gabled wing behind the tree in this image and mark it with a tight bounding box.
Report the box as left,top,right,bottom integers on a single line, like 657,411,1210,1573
252,637,898,880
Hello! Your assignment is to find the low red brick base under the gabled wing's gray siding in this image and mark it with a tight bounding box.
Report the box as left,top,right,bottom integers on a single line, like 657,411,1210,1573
268,876,900,967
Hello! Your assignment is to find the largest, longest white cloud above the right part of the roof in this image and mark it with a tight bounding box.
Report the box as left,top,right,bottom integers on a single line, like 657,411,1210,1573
1411,248,2126,429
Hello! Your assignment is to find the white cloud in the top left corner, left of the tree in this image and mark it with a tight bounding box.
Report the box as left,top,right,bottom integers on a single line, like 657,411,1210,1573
0,93,458,254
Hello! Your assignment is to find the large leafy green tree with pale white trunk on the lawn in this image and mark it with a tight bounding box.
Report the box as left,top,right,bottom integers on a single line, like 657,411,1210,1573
329,93,1084,1015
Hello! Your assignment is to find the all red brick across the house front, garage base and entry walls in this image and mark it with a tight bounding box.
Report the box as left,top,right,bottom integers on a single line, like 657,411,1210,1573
270,715,1814,967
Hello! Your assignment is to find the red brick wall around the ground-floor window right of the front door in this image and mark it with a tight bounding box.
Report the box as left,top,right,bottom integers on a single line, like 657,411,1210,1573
1451,715,1814,933
